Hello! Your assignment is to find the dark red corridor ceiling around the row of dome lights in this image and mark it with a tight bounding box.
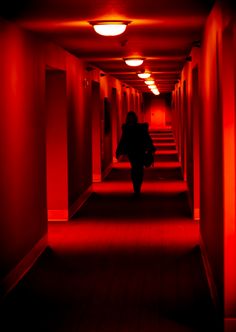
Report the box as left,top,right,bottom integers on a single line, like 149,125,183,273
0,0,214,92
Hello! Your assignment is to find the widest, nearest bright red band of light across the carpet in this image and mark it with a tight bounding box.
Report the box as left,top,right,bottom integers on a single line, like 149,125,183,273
49,220,199,251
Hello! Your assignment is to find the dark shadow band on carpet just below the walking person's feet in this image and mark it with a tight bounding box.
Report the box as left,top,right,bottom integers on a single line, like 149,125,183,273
73,192,191,223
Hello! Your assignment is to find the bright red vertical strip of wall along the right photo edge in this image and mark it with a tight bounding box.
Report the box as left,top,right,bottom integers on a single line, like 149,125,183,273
220,16,236,324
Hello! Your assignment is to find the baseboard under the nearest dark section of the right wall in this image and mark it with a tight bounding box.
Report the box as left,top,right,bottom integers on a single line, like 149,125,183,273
200,238,220,311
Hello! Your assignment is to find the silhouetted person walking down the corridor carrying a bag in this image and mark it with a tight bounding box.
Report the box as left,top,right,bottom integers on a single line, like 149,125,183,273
116,111,156,194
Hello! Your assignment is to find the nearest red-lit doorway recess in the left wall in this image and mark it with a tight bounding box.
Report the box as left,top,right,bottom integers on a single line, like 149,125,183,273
45,69,68,221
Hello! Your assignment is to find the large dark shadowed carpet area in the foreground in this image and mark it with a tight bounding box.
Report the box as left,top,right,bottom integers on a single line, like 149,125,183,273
1,246,221,332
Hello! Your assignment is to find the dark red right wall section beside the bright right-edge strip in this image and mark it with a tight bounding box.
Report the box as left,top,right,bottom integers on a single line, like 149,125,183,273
200,3,224,303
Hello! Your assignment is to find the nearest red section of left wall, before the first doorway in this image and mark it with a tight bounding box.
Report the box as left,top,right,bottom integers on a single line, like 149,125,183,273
0,22,47,278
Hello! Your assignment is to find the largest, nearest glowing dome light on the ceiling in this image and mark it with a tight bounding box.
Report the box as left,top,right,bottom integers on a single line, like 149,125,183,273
89,20,131,36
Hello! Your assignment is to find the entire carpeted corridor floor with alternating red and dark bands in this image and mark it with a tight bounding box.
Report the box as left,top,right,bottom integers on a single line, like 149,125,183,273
1,133,222,332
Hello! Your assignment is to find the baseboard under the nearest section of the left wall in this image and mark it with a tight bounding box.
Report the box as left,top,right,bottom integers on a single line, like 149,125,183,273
0,235,48,301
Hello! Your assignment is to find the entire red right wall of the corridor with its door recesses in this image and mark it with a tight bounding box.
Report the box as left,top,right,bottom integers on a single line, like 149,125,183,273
173,2,236,331
